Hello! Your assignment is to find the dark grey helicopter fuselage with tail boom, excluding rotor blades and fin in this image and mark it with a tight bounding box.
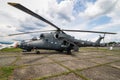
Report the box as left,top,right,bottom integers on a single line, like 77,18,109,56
18,32,103,51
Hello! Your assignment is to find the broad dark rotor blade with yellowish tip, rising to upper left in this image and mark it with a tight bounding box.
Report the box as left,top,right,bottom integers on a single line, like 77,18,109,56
8,2,60,30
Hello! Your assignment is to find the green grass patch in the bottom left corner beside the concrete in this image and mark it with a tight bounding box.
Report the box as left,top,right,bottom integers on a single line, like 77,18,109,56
0,66,15,80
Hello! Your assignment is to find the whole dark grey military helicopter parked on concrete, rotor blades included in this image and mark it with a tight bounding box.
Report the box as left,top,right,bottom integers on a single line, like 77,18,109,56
8,2,116,54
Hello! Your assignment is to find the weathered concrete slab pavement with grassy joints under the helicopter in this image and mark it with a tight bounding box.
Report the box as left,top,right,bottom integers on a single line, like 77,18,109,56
0,48,120,80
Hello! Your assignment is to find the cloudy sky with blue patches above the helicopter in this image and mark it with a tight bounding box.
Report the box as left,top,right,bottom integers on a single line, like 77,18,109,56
0,0,120,42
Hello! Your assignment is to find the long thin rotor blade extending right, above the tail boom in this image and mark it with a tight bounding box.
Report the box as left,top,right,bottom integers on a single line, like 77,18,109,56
62,29,117,34
